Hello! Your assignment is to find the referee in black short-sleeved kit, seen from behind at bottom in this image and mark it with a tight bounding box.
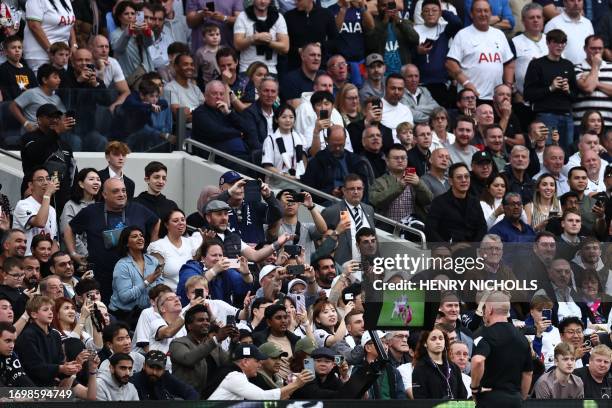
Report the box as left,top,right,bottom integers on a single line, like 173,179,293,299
471,292,533,408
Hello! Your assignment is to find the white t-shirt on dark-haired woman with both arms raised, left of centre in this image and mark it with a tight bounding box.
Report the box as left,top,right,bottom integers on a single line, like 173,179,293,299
147,235,198,291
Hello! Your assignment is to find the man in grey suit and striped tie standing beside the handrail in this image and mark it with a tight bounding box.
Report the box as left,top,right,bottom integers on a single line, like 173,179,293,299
321,174,374,264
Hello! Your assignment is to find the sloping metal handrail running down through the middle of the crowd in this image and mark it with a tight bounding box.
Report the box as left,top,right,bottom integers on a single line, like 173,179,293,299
179,138,427,249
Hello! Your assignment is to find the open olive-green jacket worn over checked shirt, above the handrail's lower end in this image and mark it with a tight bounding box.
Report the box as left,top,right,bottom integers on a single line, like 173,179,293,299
369,173,433,221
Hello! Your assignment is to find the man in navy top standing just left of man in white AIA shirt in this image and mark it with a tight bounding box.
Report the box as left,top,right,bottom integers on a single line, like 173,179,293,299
414,0,463,106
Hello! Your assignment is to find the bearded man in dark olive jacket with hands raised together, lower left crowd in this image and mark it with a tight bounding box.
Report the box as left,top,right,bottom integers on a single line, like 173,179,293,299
170,305,237,394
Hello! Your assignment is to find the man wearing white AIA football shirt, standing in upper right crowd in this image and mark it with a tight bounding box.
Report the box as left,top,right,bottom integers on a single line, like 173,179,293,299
446,0,514,100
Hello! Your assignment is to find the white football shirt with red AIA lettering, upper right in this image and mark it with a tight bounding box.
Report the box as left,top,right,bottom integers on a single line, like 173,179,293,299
447,25,513,99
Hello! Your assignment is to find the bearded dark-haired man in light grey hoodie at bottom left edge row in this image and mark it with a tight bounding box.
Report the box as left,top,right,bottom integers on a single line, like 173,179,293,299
96,353,138,401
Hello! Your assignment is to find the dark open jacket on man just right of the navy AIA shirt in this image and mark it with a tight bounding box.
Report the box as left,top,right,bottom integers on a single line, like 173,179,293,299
365,16,419,65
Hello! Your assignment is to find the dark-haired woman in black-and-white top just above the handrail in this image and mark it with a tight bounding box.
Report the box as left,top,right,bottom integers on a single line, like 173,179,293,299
262,103,307,187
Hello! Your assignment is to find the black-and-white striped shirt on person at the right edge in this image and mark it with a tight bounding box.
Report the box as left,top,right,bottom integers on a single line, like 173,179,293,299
572,60,612,127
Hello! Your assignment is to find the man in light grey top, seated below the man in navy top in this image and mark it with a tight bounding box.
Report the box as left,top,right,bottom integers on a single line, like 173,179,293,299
400,64,440,123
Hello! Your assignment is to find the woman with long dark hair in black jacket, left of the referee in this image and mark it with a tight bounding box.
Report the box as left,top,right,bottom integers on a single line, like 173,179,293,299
412,329,467,399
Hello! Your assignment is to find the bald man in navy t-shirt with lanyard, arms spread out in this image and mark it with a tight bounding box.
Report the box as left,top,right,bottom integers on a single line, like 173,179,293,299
64,177,159,304
